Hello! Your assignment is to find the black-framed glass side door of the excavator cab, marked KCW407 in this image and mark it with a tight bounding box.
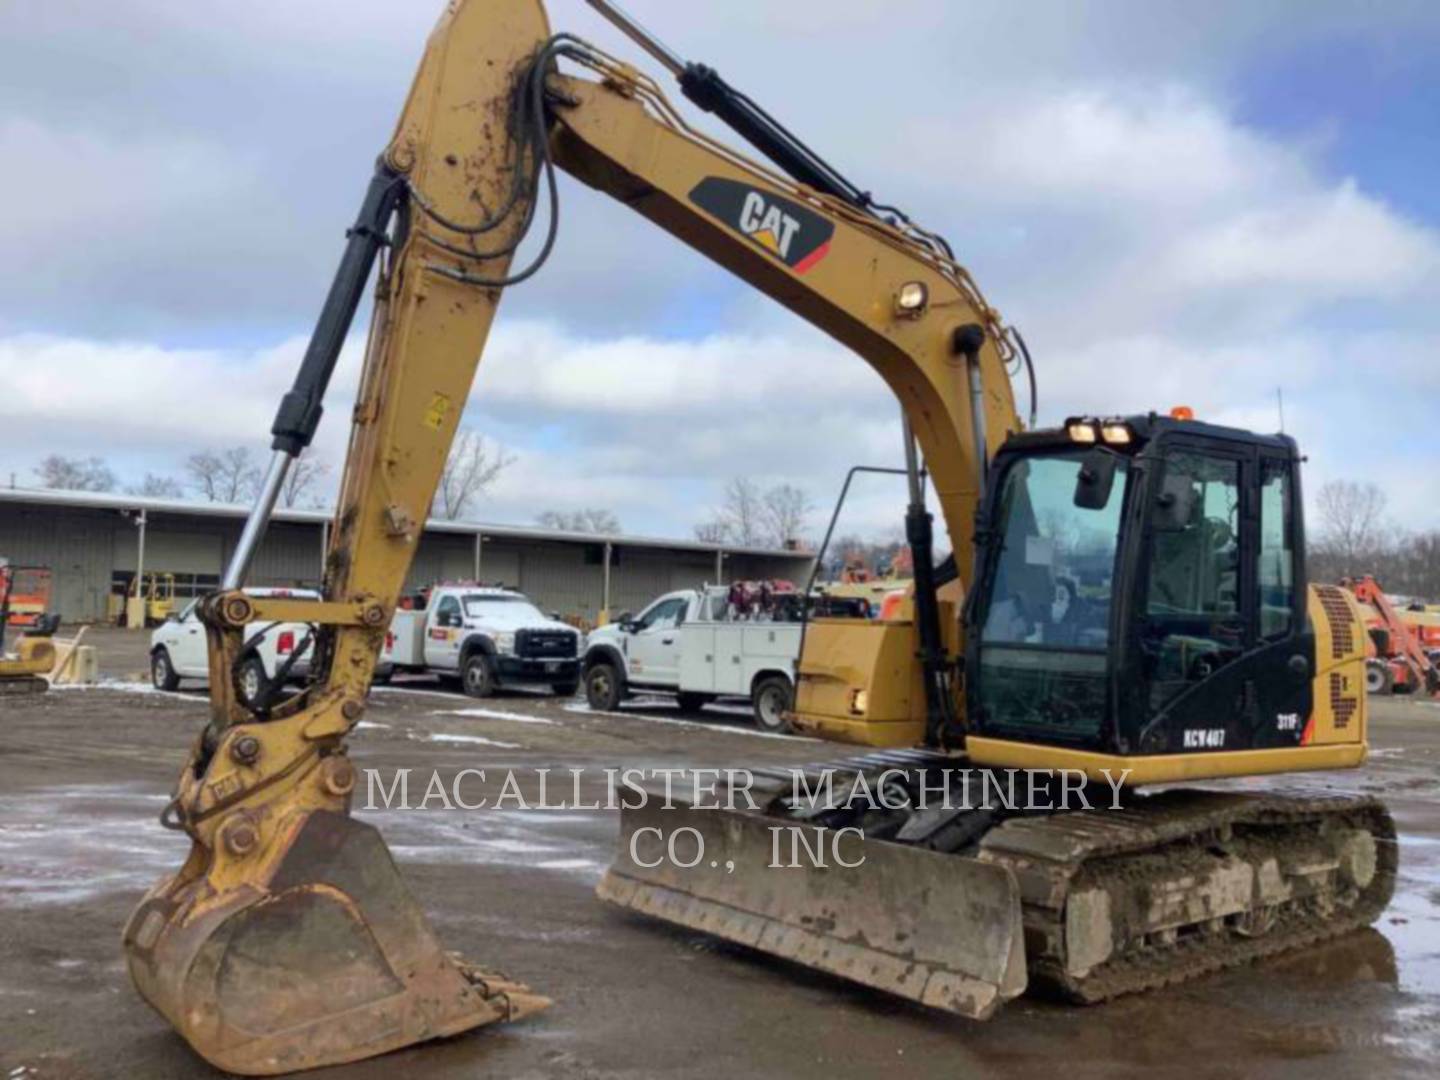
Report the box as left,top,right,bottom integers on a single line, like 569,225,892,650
1120,439,1315,753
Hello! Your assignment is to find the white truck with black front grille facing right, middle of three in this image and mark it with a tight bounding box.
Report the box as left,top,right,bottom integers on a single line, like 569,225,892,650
390,585,580,697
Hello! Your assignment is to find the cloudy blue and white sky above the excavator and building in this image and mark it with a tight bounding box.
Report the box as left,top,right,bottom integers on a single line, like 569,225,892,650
0,0,1440,536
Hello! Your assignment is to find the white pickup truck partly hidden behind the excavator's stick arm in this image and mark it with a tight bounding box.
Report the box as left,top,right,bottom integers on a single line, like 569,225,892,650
150,589,390,701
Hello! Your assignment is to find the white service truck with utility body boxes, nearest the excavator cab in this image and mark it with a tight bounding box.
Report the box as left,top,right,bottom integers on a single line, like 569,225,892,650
582,586,801,732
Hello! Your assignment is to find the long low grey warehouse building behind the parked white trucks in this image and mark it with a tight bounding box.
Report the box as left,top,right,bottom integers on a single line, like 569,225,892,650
0,488,811,622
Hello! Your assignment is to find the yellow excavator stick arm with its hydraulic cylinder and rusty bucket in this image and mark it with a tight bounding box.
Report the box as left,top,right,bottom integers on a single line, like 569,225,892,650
124,0,550,1074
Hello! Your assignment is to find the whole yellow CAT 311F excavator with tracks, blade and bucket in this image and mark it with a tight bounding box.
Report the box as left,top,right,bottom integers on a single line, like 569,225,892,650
124,0,1395,1074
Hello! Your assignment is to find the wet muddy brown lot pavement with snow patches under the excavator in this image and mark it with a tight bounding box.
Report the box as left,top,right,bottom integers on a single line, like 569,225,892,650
0,622,1440,1080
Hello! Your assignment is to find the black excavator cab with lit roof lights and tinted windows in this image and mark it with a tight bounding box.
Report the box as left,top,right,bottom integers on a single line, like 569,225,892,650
965,416,1316,757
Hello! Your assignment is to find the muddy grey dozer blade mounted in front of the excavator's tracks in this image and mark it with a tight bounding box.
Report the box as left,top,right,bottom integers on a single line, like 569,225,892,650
596,801,1025,1020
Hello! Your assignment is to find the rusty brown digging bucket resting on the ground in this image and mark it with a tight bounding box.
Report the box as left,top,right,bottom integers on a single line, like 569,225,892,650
125,811,550,1076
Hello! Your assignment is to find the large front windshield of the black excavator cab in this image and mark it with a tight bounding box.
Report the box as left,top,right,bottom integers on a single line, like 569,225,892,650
978,451,1128,739
